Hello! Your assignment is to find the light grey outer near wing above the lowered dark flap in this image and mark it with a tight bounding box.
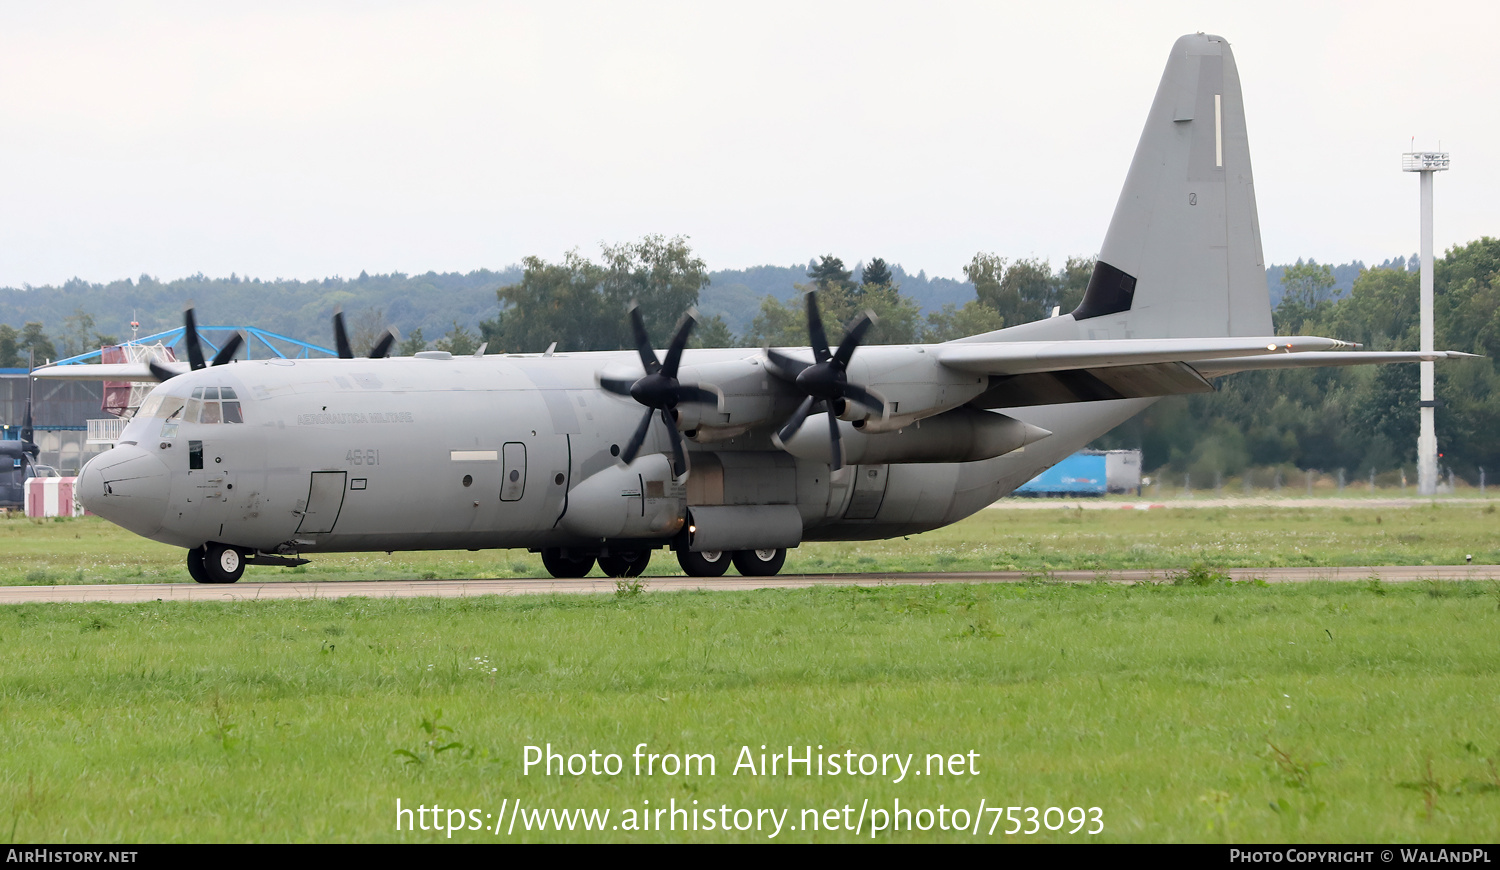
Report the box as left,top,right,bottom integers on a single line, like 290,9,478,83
938,336,1358,375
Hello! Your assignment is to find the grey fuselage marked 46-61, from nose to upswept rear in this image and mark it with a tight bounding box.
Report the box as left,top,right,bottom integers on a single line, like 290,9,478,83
80,348,1151,554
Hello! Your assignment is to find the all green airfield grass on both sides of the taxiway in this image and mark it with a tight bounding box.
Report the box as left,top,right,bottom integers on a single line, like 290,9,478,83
0,504,1500,843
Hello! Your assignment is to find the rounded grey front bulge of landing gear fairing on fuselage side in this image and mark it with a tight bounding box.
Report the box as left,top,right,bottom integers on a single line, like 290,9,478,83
563,453,687,540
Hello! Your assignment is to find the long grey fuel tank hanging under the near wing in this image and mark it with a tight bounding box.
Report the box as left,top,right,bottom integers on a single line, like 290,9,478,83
782,405,1052,465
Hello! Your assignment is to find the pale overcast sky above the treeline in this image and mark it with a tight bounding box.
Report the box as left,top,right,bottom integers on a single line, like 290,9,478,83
0,0,1500,287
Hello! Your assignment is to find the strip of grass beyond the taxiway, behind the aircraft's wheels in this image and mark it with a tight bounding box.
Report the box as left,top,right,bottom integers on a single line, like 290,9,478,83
0,501,1500,585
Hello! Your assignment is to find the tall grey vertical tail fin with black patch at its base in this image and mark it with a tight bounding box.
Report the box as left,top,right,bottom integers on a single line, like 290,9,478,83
1073,33,1272,338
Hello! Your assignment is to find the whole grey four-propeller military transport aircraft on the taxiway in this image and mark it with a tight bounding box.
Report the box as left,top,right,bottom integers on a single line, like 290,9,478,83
36,33,1467,584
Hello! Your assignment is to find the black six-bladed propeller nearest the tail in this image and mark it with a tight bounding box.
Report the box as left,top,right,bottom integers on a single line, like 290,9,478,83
765,293,885,471
